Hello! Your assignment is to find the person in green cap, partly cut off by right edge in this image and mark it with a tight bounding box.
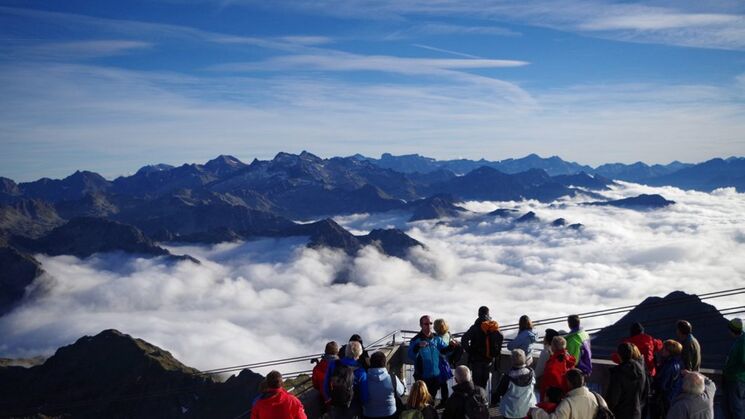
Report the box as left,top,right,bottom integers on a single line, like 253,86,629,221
722,318,745,419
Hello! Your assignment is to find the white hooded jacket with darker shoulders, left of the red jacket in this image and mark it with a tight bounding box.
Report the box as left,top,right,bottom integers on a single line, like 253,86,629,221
497,365,536,418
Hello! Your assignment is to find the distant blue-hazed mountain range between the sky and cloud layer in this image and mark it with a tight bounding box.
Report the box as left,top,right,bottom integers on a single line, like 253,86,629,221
0,151,745,313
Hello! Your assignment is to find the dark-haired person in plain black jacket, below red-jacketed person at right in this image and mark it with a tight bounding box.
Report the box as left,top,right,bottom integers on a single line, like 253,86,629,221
606,342,647,419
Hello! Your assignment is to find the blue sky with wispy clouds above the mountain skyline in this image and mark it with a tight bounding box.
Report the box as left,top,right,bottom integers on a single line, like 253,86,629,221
0,0,745,181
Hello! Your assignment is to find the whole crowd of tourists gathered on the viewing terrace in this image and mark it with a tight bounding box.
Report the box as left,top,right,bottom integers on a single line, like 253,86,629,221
251,307,745,419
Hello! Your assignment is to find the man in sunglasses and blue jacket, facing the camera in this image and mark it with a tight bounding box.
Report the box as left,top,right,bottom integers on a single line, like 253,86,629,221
409,315,448,399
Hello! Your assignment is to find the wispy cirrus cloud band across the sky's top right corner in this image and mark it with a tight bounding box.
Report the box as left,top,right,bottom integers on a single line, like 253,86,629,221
247,0,745,50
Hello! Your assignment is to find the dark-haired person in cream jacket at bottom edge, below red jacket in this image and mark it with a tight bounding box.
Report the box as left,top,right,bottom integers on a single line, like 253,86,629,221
530,368,605,419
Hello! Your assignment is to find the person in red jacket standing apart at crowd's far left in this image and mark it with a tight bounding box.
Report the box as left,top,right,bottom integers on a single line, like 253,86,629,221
251,371,308,419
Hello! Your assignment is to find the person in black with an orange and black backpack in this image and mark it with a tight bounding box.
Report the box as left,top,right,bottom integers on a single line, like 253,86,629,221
461,306,504,396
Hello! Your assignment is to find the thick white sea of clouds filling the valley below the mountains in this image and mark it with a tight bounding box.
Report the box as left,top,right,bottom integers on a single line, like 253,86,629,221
0,183,745,376
